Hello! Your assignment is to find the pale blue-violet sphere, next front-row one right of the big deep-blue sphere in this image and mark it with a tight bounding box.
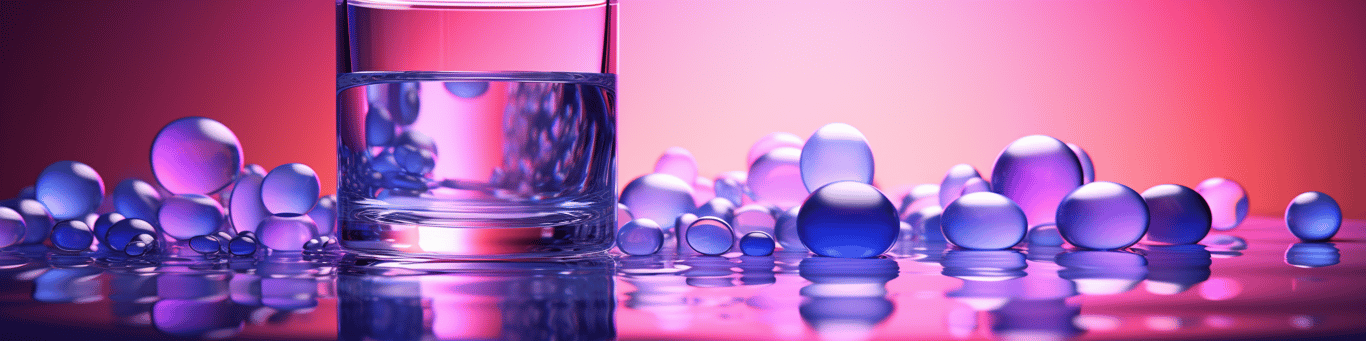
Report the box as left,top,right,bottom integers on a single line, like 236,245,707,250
945,192,1027,250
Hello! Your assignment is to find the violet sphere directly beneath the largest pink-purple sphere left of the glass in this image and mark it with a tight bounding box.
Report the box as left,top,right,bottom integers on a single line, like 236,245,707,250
157,194,223,240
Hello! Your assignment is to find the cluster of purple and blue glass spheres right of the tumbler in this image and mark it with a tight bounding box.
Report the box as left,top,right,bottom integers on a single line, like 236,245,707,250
617,123,1341,258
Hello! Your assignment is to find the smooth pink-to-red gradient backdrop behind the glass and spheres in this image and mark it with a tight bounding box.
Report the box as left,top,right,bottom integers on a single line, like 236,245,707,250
0,0,1366,218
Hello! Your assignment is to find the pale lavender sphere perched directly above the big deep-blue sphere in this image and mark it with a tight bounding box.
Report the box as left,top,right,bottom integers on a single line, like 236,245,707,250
800,123,873,191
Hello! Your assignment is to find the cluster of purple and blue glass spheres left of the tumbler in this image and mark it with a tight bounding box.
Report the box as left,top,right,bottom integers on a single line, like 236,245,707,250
0,117,336,258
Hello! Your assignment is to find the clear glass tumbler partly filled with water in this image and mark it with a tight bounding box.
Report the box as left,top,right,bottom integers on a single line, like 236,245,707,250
336,0,616,259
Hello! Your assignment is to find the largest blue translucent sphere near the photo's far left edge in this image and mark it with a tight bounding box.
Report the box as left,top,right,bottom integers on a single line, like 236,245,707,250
34,161,104,220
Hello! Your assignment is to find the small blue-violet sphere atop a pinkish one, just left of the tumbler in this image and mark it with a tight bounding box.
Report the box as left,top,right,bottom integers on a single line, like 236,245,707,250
261,164,322,214
